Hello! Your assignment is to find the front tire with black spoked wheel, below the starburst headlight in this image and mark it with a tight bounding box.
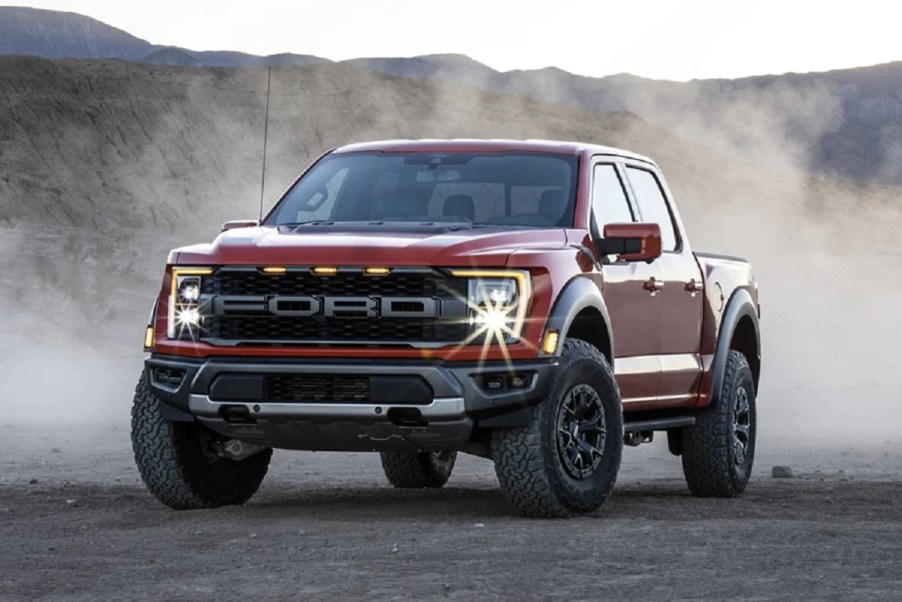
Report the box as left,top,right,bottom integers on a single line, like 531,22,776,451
492,339,623,518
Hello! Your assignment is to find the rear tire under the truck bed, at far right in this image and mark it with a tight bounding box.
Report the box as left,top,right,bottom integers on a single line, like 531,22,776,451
682,351,757,498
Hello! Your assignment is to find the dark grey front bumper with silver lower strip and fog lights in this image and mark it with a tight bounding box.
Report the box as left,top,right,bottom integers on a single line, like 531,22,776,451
145,355,557,451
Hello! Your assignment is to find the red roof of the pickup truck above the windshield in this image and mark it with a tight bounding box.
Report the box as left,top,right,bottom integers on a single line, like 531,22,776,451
334,139,654,163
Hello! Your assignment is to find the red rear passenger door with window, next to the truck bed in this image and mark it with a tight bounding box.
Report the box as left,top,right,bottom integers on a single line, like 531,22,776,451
626,166,704,405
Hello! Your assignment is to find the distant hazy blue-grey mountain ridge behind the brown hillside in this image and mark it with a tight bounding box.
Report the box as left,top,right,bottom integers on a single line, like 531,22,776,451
0,7,902,184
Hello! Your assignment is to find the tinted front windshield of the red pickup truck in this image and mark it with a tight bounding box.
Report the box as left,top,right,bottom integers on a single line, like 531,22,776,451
265,152,577,228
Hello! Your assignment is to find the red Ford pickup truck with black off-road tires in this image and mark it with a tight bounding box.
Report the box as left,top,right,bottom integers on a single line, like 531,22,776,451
132,140,761,517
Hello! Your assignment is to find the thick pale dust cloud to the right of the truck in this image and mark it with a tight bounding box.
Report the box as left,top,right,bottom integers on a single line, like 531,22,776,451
648,84,902,449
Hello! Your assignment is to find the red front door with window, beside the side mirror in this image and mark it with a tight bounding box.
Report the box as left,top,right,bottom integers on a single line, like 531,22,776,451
591,163,663,404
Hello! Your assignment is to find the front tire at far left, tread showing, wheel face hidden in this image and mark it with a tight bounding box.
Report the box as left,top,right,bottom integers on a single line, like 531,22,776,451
132,374,272,510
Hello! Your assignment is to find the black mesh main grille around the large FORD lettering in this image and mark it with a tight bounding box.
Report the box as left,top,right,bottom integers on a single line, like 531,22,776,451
201,268,469,345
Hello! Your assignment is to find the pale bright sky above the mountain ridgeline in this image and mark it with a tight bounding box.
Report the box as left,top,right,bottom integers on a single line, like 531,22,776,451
12,0,902,81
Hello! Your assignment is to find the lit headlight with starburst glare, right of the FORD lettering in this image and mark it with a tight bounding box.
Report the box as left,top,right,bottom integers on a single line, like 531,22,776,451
452,270,530,343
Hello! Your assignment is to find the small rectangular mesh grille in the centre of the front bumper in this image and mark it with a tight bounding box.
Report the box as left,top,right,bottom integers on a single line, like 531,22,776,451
266,374,370,403
